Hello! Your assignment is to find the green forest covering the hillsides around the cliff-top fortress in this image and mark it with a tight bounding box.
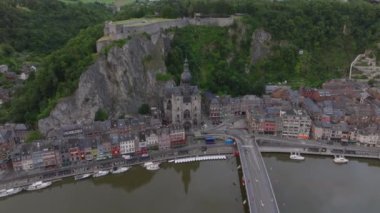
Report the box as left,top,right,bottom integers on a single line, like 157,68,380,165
0,0,380,124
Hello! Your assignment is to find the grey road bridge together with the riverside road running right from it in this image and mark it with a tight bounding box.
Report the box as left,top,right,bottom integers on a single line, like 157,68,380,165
207,125,380,213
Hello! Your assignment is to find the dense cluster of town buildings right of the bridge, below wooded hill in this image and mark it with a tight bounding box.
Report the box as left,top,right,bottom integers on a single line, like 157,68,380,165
247,79,380,146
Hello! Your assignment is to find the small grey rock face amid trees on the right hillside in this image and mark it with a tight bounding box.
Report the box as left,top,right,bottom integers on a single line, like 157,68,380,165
251,29,272,64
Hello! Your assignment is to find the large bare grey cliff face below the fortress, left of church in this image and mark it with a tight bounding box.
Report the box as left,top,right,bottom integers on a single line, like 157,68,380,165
38,33,170,135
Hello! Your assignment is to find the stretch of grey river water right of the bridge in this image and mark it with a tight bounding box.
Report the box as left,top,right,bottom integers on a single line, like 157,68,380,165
264,154,380,213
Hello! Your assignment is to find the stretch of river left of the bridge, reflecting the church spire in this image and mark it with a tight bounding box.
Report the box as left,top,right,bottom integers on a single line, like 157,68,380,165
0,159,243,213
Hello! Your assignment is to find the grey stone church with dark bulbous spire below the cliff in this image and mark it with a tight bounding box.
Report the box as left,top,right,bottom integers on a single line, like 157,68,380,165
163,58,201,130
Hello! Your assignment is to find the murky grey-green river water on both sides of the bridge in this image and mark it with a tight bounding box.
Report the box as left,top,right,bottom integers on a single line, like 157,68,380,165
0,154,380,213
